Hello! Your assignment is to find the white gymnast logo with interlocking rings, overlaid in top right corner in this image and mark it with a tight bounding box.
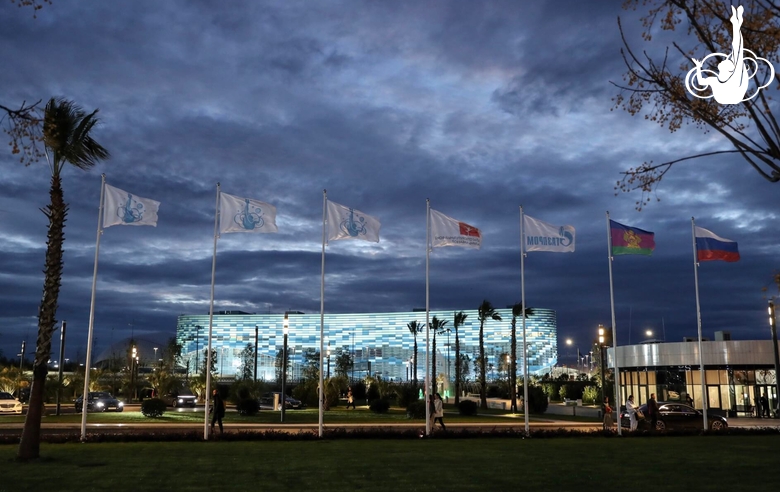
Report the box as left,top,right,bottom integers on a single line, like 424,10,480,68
685,5,775,104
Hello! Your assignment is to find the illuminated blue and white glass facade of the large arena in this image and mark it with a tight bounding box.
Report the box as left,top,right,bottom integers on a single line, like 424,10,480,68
176,308,558,381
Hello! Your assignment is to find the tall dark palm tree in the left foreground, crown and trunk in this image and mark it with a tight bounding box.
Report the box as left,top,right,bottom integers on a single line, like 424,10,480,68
18,98,109,460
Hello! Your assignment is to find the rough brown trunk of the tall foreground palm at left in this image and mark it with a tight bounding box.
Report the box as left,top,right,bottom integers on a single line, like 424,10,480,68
17,175,68,460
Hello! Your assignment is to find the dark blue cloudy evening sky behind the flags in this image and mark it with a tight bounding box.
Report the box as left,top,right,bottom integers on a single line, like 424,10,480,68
0,0,780,366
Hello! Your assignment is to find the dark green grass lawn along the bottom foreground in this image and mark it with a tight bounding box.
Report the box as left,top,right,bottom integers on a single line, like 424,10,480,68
0,435,780,492
